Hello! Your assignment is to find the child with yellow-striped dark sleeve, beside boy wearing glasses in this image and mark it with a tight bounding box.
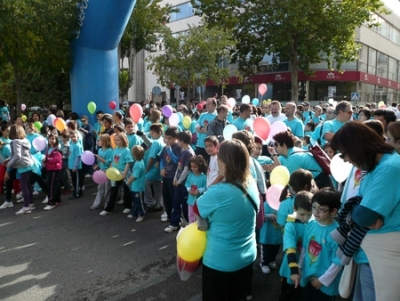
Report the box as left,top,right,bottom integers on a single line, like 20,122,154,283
279,191,312,301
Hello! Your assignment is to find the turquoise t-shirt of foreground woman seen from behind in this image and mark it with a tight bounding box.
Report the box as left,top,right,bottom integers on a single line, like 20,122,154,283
197,180,259,272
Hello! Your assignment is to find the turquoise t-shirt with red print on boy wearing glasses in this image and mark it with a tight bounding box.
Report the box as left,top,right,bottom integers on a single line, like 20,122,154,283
300,220,342,296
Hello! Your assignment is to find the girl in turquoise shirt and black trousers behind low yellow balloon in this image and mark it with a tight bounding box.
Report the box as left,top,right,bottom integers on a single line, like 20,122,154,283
100,133,133,216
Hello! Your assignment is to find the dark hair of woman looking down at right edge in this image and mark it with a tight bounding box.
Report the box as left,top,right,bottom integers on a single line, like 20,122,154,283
331,121,394,172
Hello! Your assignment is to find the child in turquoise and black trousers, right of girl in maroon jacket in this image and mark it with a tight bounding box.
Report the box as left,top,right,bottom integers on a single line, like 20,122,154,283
68,131,84,199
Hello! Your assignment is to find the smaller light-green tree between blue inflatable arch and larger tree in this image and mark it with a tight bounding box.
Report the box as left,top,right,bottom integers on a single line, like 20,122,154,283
148,24,234,101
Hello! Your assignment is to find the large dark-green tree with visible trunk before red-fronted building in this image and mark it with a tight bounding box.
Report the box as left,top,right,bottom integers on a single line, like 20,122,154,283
192,0,387,101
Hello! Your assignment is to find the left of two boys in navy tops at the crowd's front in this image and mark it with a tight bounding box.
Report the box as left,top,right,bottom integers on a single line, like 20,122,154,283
160,126,181,222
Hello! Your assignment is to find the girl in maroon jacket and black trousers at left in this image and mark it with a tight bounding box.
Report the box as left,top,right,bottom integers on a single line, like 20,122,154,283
43,134,62,210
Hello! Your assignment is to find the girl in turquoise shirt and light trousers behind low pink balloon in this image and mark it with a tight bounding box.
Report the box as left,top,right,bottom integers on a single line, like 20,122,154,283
90,134,112,210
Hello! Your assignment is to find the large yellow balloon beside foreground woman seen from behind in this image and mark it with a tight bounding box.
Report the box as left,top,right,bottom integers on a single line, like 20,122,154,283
176,223,206,262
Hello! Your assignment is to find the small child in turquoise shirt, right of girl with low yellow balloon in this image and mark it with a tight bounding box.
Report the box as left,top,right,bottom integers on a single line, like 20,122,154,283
127,145,146,223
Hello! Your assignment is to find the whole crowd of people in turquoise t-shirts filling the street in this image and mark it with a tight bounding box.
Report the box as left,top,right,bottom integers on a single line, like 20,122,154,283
0,95,400,301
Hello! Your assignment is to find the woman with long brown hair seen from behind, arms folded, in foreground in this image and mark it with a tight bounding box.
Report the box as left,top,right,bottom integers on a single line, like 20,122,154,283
197,139,259,300
